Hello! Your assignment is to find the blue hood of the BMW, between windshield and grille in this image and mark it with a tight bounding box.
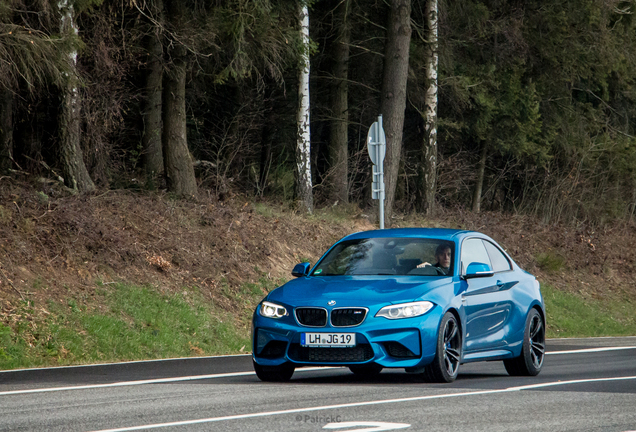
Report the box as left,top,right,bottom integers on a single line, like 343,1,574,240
268,276,453,307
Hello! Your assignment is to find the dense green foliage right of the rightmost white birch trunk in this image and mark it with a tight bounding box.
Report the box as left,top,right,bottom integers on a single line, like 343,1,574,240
432,0,636,223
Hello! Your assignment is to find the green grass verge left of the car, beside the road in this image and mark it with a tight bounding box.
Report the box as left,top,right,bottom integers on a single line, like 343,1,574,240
0,285,262,369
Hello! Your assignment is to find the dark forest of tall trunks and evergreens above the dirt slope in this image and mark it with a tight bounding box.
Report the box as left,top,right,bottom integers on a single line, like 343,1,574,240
0,0,636,226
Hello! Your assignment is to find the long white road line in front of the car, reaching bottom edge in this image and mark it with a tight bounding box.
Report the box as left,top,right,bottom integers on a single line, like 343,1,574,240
88,376,636,432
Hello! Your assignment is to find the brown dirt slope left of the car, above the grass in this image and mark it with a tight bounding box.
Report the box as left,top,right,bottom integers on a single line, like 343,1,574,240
0,183,372,313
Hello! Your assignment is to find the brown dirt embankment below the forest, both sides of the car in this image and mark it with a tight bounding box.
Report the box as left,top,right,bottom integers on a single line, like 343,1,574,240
0,179,636,321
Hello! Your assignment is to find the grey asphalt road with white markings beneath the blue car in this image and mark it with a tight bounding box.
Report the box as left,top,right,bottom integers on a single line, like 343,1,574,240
0,337,636,432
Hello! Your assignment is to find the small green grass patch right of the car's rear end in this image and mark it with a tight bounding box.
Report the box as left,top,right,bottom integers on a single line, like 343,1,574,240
541,284,636,338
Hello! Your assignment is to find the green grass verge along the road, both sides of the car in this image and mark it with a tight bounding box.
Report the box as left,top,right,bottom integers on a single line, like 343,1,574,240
0,278,636,370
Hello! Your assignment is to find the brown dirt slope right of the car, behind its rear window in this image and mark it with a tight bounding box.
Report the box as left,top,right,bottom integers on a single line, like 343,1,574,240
444,213,636,299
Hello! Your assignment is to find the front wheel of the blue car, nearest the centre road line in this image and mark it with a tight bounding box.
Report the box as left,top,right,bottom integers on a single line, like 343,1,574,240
423,312,462,383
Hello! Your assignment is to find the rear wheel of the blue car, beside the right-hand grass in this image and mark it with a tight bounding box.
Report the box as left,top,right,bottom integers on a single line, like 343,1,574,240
504,308,545,376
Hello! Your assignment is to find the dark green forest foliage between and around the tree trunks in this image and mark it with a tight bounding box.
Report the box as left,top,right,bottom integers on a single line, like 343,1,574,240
0,0,636,224
